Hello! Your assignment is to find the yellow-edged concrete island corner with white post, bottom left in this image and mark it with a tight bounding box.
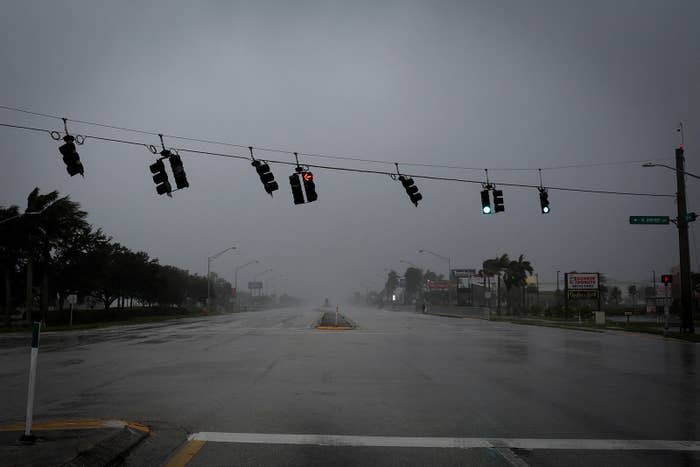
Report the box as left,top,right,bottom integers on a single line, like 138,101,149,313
0,419,150,467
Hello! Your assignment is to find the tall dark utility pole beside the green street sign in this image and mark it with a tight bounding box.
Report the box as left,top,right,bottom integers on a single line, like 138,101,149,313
676,144,695,334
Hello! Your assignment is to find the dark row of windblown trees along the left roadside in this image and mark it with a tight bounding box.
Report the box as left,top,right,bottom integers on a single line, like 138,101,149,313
0,188,231,326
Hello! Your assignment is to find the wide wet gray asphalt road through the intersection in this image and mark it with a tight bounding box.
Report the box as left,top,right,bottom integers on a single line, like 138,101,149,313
0,307,700,465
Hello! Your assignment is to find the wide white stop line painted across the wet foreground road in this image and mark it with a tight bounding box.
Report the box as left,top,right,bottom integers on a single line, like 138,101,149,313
188,431,700,451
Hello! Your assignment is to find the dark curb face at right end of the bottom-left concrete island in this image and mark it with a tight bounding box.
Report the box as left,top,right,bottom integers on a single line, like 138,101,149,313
63,423,151,467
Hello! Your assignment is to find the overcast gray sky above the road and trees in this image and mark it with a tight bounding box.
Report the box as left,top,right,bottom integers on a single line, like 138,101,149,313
0,0,700,298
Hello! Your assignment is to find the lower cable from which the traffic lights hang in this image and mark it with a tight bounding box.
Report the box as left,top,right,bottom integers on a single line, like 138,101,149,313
0,119,675,198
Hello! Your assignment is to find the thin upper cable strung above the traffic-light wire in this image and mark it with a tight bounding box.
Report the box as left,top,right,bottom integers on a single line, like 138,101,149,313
0,105,673,172
